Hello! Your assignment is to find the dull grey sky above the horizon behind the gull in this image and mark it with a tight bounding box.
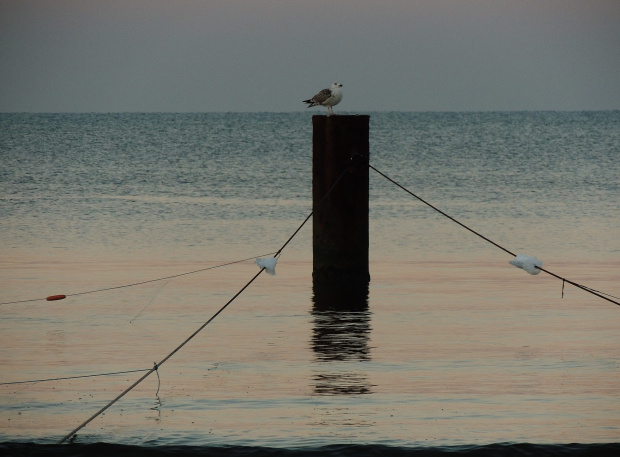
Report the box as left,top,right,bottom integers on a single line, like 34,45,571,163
0,0,620,113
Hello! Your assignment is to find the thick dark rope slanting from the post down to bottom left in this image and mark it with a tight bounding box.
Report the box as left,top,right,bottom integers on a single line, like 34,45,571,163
58,169,347,444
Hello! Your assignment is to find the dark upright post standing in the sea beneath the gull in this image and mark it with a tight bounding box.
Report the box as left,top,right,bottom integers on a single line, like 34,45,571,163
312,115,370,287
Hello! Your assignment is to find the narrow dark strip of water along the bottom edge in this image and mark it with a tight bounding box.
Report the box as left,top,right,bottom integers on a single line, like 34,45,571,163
0,443,620,457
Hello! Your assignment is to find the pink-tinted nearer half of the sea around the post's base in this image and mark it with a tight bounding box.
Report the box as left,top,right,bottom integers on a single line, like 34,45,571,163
0,253,620,444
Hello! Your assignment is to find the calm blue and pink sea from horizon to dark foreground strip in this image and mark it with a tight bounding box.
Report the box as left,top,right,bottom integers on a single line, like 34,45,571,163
0,111,620,456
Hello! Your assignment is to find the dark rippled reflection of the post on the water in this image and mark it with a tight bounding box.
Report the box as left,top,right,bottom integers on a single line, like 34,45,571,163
311,281,372,395
